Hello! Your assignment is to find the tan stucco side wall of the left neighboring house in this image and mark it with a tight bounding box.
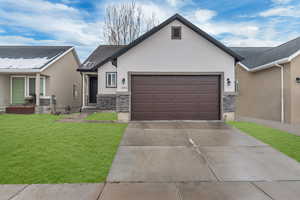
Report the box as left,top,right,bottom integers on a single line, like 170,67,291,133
42,51,82,109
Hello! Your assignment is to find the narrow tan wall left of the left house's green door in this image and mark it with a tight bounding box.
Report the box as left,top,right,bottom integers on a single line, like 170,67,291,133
0,74,10,107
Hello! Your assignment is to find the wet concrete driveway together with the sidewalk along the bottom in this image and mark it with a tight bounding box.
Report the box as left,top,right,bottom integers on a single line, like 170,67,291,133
0,122,300,200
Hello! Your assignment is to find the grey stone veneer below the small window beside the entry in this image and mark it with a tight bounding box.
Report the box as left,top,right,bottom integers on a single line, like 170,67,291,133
96,94,116,110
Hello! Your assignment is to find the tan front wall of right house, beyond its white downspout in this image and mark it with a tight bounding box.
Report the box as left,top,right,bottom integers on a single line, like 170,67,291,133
290,56,300,124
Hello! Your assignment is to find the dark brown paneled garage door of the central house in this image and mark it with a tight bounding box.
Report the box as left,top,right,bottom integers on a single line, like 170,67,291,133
131,75,220,120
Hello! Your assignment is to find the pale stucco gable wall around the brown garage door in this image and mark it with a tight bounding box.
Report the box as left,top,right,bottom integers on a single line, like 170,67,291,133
117,21,235,92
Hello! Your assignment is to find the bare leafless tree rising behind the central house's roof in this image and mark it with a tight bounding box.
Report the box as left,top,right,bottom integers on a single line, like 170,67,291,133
103,0,158,45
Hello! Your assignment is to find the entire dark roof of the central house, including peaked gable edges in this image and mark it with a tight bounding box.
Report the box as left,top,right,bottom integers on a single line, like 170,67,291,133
78,14,243,71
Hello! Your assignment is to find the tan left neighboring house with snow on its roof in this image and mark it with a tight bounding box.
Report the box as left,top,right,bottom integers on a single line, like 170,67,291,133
0,46,82,112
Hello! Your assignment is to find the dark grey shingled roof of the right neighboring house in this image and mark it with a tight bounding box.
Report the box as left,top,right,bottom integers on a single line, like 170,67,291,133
231,37,300,69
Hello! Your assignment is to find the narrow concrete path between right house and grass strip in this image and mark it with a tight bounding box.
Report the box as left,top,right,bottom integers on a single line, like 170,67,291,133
238,117,300,136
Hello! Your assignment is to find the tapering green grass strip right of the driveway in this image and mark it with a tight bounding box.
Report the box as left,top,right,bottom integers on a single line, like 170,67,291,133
228,122,300,162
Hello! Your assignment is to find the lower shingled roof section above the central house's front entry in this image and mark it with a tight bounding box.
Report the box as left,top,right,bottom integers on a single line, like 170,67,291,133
79,45,125,71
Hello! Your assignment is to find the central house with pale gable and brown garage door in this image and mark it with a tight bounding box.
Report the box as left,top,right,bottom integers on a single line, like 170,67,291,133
78,14,242,120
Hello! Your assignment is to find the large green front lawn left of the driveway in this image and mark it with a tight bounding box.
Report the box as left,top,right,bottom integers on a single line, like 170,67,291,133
0,114,127,184
